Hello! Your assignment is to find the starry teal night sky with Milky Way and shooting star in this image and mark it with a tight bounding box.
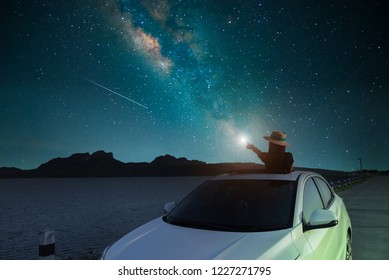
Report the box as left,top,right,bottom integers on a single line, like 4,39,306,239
0,0,389,171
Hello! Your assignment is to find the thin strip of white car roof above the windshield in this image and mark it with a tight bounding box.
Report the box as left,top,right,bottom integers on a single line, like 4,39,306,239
211,170,317,181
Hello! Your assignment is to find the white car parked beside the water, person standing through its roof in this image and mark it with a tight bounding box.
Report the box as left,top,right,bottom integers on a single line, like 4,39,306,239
102,171,352,260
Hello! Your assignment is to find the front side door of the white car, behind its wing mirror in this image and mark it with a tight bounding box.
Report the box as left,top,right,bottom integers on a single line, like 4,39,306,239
303,177,339,260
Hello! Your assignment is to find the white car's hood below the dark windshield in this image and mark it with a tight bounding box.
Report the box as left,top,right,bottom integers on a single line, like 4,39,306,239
104,218,299,260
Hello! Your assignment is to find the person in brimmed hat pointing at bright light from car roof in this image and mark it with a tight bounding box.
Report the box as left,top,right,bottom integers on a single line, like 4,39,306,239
246,130,294,173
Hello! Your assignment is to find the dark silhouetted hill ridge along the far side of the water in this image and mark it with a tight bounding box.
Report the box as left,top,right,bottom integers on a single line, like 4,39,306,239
0,151,263,178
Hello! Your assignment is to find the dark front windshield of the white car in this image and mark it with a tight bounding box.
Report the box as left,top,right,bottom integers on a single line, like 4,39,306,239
164,180,296,231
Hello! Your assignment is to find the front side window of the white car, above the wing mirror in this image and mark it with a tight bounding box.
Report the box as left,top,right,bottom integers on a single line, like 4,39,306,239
303,178,324,223
